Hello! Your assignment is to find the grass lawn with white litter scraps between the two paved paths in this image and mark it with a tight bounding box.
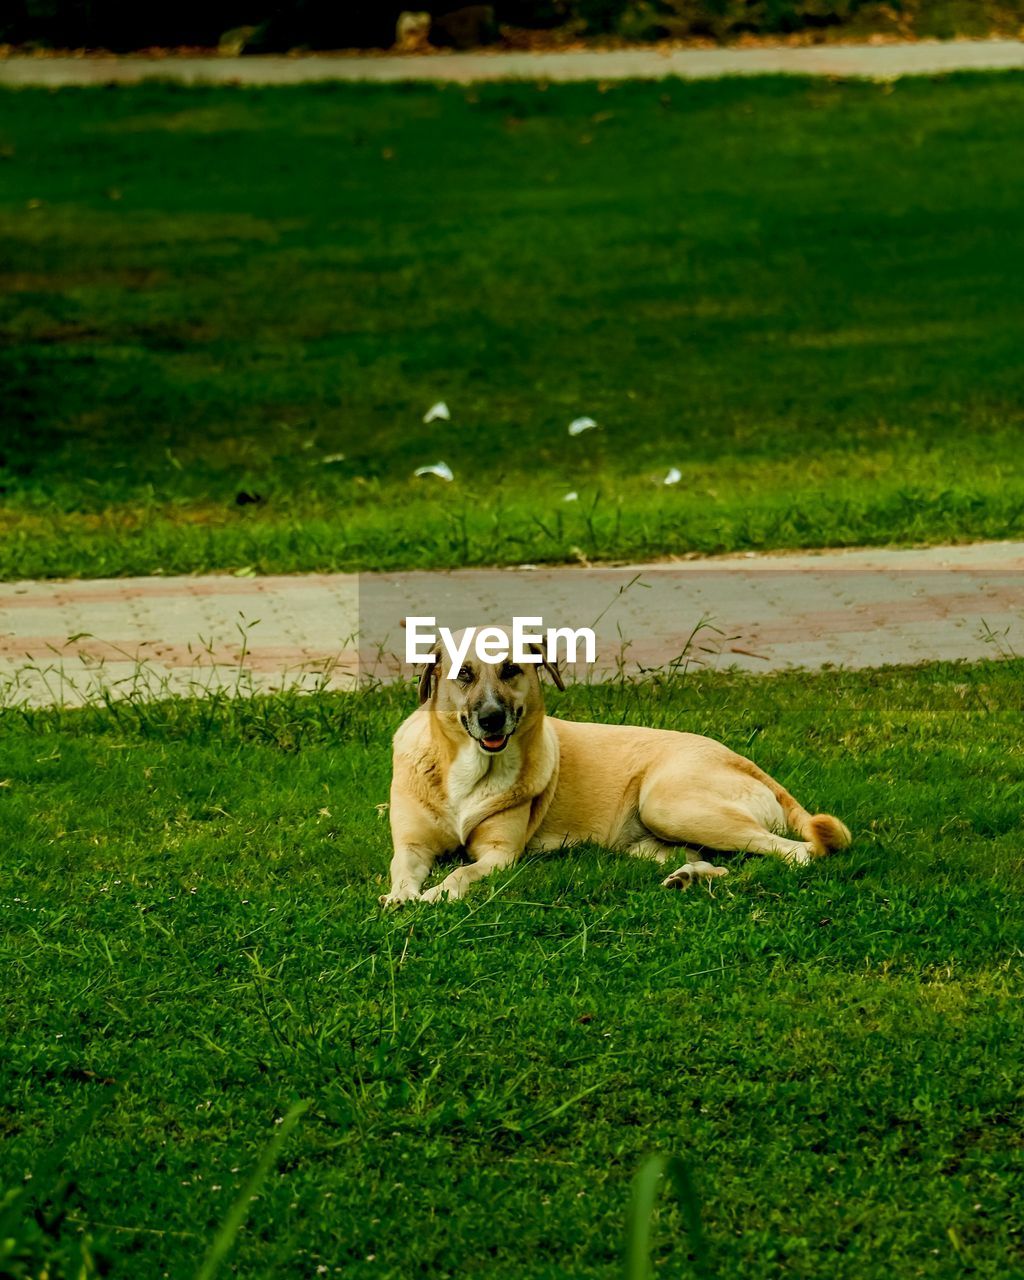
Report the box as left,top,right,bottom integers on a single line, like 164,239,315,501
0,74,1024,579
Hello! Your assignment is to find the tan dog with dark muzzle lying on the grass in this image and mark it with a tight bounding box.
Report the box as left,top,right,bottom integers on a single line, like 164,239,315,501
381,627,850,906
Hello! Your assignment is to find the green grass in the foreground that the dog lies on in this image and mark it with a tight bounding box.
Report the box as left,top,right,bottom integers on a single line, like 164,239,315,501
0,660,1024,1280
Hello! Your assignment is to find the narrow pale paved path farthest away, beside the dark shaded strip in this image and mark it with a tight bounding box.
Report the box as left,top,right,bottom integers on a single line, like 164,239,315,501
0,40,1024,86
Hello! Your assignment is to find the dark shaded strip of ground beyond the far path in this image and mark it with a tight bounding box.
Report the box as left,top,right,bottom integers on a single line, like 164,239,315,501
8,0,1024,54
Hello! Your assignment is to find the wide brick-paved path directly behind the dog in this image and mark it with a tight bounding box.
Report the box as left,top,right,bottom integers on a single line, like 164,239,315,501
0,543,1024,705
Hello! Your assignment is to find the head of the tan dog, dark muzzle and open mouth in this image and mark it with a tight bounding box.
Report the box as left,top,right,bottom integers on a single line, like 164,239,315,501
420,627,564,755
